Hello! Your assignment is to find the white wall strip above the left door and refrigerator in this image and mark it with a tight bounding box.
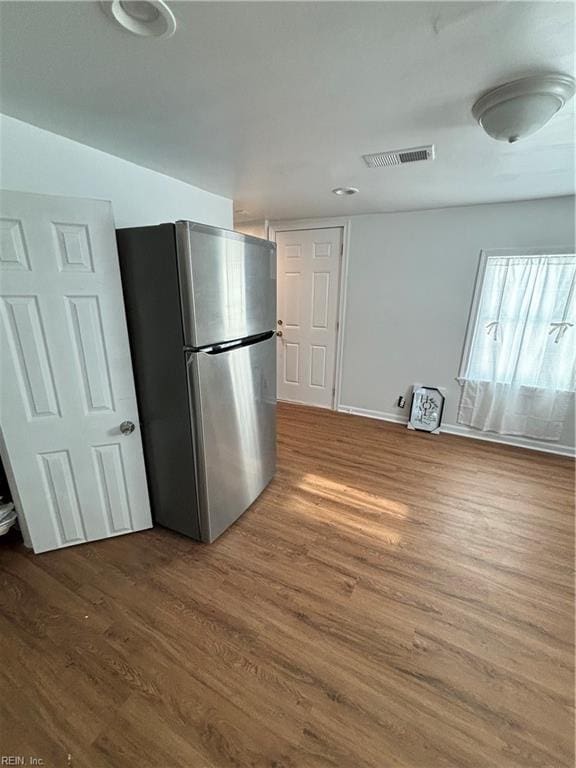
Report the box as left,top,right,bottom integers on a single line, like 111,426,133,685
0,115,232,229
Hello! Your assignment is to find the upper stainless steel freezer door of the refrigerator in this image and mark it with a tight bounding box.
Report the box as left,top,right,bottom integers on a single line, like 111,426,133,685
176,221,276,347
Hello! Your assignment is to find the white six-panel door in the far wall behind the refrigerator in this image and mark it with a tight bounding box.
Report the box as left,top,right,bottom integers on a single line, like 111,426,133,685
276,227,342,408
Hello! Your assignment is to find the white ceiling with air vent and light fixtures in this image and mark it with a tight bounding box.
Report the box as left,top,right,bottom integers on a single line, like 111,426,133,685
0,2,575,219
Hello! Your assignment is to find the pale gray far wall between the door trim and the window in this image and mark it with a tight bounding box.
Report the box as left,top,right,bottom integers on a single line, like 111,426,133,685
340,197,574,446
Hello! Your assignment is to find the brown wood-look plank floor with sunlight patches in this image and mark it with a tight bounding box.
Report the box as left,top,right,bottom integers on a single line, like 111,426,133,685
0,406,574,768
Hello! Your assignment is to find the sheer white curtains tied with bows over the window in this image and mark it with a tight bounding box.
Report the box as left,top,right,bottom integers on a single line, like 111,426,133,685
458,254,576,440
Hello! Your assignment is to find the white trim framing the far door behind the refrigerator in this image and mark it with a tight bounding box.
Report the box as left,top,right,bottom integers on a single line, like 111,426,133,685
268,216,352,411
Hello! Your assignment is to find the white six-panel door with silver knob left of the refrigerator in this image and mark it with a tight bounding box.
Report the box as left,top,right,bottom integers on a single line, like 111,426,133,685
0,192,152,552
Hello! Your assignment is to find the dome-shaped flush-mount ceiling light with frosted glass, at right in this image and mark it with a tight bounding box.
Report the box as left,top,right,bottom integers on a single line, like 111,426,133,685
472,74,574,144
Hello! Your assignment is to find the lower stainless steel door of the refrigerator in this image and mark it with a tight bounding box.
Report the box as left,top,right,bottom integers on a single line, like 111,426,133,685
187,336,276,542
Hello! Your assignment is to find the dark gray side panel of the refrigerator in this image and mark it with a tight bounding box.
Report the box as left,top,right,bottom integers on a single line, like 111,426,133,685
117,224,200,539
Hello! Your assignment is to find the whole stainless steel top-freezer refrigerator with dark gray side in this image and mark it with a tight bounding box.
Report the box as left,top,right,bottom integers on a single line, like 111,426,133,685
117,221,276,542
